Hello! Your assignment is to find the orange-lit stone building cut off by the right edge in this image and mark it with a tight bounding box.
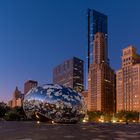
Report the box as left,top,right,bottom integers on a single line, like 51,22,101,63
116,46,140,112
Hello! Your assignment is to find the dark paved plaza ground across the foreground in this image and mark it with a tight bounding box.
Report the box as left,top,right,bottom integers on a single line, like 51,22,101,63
0,121,140,140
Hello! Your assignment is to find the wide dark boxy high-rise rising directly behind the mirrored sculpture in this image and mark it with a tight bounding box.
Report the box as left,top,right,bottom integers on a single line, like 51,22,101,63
53,57,84,92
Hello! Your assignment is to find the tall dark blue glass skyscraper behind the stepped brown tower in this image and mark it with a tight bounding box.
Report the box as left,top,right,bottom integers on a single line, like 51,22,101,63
88,9,108,72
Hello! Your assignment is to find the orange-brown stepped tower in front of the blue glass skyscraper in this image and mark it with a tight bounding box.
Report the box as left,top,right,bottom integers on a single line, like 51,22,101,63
87,32,115,113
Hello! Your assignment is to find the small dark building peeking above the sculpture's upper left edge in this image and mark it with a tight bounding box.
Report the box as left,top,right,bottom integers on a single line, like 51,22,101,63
24,80,38,95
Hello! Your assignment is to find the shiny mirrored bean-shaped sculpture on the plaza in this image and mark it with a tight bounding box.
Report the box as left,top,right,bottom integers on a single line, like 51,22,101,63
23,84,86,123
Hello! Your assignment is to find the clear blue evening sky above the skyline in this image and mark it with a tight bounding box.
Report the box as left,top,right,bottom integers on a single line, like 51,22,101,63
0,0,140,101
